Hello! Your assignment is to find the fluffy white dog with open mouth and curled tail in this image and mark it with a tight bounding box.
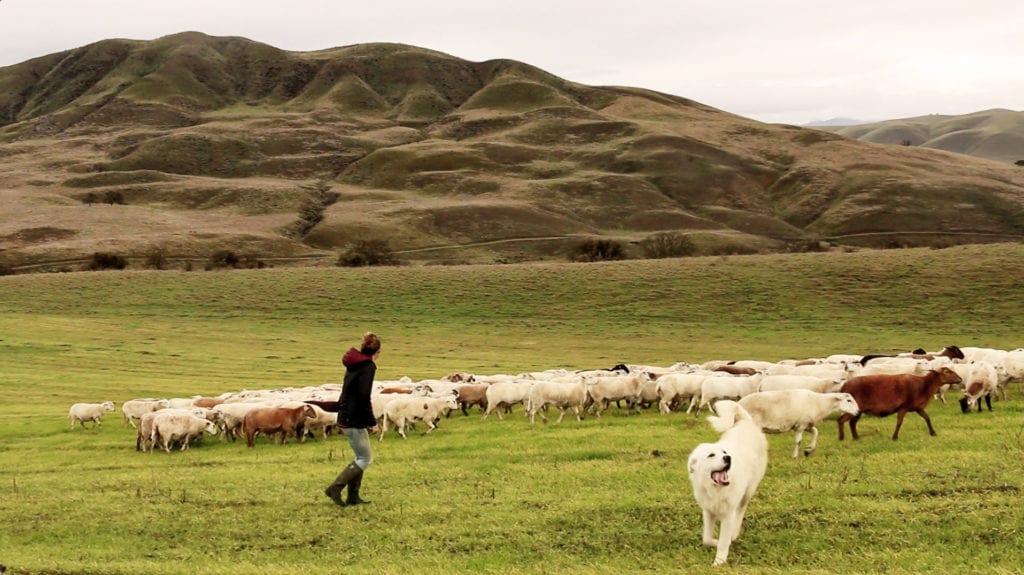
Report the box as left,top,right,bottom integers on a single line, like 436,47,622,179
687,400,768,565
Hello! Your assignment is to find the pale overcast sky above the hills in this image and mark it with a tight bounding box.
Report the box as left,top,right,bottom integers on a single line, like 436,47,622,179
0,0,1024,124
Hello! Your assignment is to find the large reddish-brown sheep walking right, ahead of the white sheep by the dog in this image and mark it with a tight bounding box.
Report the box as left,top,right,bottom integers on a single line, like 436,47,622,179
839,367,963,441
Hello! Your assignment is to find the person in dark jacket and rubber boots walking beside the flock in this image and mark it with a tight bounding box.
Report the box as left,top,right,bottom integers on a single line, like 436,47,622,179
324,331,381,506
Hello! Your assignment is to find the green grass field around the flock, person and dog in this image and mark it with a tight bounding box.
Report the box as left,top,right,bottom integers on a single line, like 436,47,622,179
0,245,1024,574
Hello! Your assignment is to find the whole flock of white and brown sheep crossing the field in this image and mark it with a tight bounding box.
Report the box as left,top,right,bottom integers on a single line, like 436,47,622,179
68,346,1024,457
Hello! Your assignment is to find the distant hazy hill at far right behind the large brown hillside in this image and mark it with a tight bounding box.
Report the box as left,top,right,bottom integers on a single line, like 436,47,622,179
819,109,1024,164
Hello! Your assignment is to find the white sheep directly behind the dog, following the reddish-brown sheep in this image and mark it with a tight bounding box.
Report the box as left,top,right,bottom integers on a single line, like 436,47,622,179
739,389,859,459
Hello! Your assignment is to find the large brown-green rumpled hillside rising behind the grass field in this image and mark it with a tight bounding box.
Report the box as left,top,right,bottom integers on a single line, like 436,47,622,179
0,33,1024,269
